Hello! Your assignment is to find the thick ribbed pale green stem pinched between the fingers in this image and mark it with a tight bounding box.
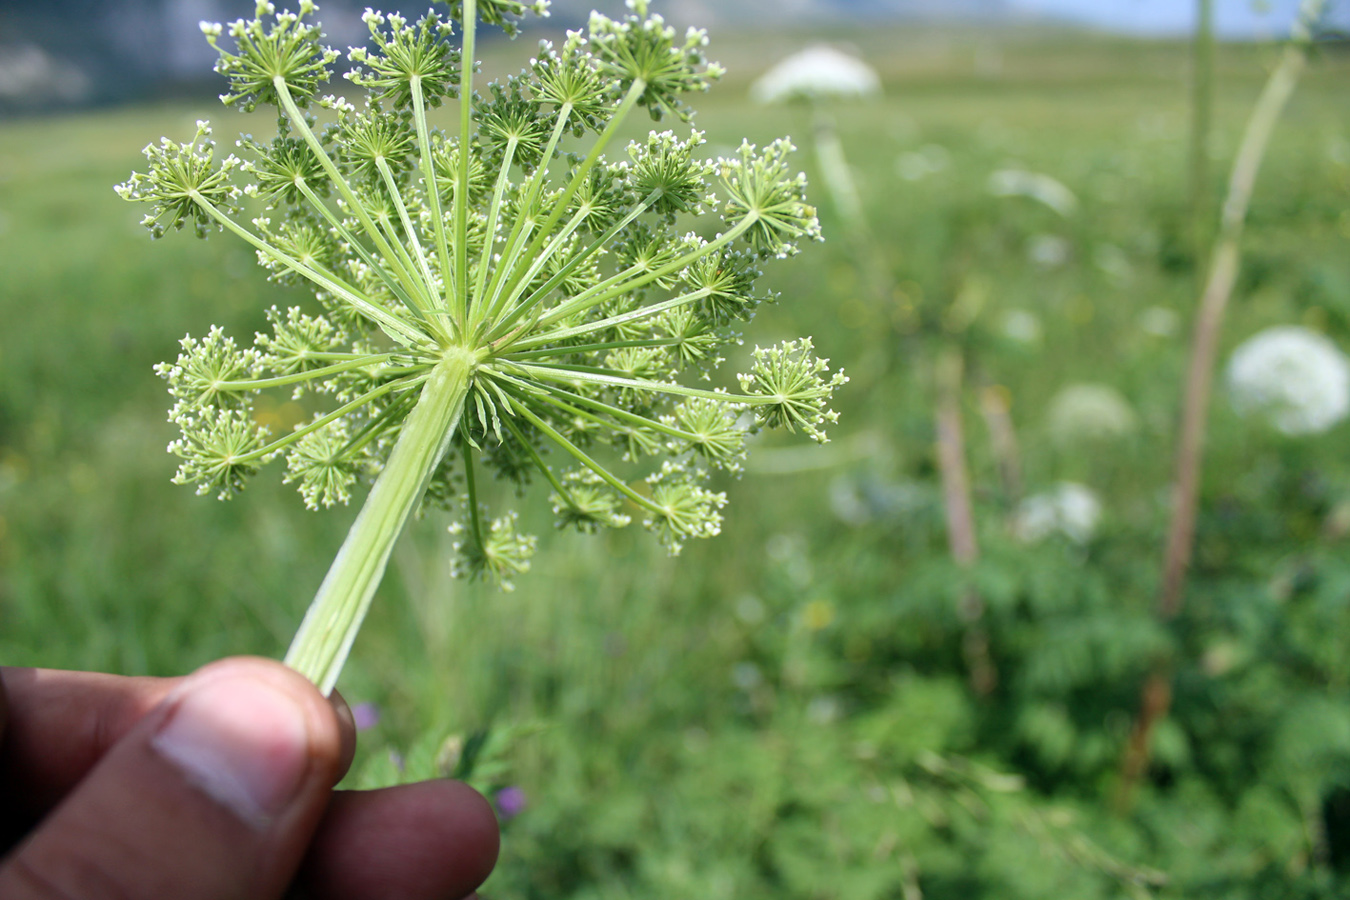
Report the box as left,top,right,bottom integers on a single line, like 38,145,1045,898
286,349,475,694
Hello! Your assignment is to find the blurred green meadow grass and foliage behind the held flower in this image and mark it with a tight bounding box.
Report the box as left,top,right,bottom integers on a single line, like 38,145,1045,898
0,31,1350,899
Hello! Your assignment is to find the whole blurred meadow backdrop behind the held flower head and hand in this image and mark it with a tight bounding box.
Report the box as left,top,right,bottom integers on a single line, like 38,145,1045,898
0,0,1350,900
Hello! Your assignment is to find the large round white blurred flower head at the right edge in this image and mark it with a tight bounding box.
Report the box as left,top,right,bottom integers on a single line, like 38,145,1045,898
1227,325,1350,434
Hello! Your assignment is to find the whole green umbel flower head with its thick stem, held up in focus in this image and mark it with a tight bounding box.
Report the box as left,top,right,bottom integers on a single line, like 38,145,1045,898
117,0,846,691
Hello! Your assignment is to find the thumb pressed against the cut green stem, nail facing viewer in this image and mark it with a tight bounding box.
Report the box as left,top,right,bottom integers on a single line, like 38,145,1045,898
0,658,340,900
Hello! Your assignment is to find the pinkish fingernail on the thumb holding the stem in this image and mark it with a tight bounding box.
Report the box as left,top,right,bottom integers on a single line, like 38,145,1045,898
150,675,309,830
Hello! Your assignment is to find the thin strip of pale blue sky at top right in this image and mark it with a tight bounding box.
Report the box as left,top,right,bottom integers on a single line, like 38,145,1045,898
1013,0,1350,38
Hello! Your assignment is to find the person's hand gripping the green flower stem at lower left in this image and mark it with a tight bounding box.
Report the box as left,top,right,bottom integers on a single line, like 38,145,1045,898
0,657,498,900
